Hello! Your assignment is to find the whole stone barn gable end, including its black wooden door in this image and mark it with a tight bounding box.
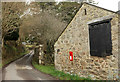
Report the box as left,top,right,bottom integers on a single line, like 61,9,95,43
54,3,118,80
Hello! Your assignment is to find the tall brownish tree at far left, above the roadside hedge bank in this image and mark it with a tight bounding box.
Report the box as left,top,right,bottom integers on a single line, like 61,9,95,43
2,2,23,41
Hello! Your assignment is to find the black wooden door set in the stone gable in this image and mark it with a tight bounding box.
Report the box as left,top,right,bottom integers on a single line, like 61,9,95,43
89,20,112,57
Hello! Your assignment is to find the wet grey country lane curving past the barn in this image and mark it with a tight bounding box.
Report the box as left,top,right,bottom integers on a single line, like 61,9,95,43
2,53,56,80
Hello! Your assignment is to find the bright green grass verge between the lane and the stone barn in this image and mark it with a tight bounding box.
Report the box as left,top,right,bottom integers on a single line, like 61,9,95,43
32,61,90,80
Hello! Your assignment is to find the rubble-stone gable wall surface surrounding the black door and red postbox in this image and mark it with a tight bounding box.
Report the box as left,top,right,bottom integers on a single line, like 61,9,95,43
54,3,118,80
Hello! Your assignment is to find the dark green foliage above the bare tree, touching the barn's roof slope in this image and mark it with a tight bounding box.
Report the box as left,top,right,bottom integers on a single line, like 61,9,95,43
39,2,81,23
